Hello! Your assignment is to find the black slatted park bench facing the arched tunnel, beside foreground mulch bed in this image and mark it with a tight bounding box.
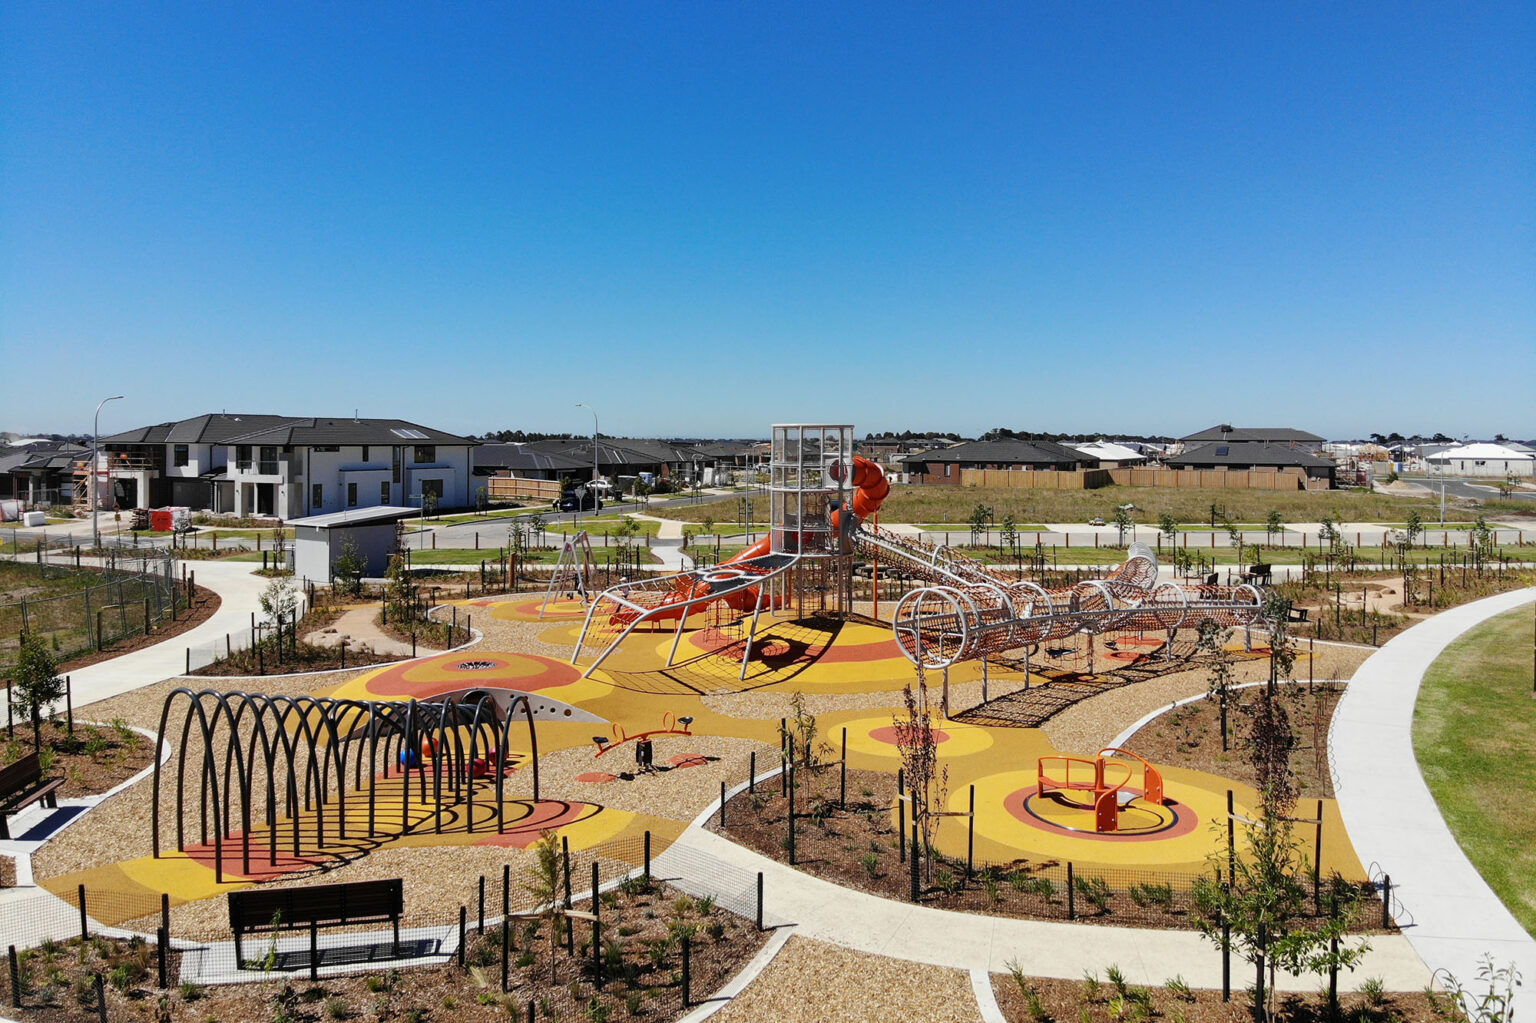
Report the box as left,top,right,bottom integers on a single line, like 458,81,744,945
229,877,406,965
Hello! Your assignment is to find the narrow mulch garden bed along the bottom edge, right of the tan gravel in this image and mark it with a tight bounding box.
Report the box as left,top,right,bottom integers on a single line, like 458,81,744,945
992,963,1461,1023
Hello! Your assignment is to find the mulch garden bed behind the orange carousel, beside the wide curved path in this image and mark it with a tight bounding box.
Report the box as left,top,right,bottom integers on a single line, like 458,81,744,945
1126,682,1344,799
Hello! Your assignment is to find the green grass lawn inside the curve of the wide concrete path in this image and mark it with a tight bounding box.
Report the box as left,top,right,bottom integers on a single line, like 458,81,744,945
1413,605,1536,935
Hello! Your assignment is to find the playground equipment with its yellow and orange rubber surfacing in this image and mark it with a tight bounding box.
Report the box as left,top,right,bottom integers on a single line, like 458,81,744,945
21,425,1364,923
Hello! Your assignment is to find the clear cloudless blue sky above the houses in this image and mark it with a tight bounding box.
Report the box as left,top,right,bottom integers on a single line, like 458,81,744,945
0,0,1536,438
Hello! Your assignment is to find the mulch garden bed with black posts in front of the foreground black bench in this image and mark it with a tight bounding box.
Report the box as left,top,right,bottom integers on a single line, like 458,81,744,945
0,879,768,1023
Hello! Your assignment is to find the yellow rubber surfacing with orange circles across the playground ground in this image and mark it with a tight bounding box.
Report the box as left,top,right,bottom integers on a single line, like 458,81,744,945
72,598,1361,902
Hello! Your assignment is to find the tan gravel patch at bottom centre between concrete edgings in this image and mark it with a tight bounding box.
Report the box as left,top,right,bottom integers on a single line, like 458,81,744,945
710,937,982,1023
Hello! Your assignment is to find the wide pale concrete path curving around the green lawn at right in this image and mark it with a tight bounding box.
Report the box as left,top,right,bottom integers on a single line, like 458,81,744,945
1329,580,1536,1001
